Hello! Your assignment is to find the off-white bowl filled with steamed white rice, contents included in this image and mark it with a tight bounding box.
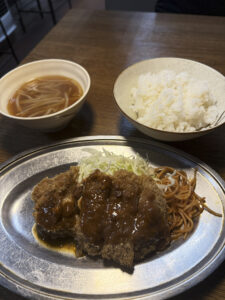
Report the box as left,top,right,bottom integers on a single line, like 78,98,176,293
113,57,225,141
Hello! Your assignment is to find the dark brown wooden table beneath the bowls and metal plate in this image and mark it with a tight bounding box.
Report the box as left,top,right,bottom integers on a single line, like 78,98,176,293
0,9,225,300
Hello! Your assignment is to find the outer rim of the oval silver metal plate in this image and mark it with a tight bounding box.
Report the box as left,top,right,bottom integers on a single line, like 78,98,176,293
0,136,225,299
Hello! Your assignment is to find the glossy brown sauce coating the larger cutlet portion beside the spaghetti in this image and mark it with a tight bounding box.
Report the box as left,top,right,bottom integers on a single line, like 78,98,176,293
80,170,167,245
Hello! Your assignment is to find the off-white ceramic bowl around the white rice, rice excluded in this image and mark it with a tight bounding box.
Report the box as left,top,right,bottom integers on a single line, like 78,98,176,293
113,57,225,141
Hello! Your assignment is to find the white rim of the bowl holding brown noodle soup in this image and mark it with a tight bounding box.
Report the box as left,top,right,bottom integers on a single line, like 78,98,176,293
0,58,91,121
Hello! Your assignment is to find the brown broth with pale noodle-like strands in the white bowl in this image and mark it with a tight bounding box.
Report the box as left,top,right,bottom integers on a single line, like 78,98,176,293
7,75,83,117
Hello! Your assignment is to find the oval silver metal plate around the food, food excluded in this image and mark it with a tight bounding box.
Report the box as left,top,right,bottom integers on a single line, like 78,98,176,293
0,136,225,299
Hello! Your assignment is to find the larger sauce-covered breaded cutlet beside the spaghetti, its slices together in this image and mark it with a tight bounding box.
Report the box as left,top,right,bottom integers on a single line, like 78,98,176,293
76,170,169,268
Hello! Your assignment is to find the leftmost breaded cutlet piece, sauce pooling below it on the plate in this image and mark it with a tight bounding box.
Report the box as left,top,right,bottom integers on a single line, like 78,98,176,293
32,166,82,239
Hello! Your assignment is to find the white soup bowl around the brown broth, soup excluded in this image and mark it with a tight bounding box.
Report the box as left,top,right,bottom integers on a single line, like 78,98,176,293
0,59,90,131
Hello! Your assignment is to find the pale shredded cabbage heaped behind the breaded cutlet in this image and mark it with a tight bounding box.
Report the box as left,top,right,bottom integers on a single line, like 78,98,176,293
79,148,153,181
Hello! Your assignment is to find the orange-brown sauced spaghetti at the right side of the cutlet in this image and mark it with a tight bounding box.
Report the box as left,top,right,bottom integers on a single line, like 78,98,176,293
155,167,222,240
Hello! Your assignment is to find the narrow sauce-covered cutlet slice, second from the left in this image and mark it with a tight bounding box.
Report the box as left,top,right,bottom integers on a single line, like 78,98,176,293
76,170,112,256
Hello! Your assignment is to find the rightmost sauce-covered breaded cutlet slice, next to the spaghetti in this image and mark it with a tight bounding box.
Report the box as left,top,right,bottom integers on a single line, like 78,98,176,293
132,176,170,261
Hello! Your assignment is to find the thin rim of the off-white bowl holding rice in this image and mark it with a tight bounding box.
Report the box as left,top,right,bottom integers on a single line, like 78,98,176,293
113,56,225,135
